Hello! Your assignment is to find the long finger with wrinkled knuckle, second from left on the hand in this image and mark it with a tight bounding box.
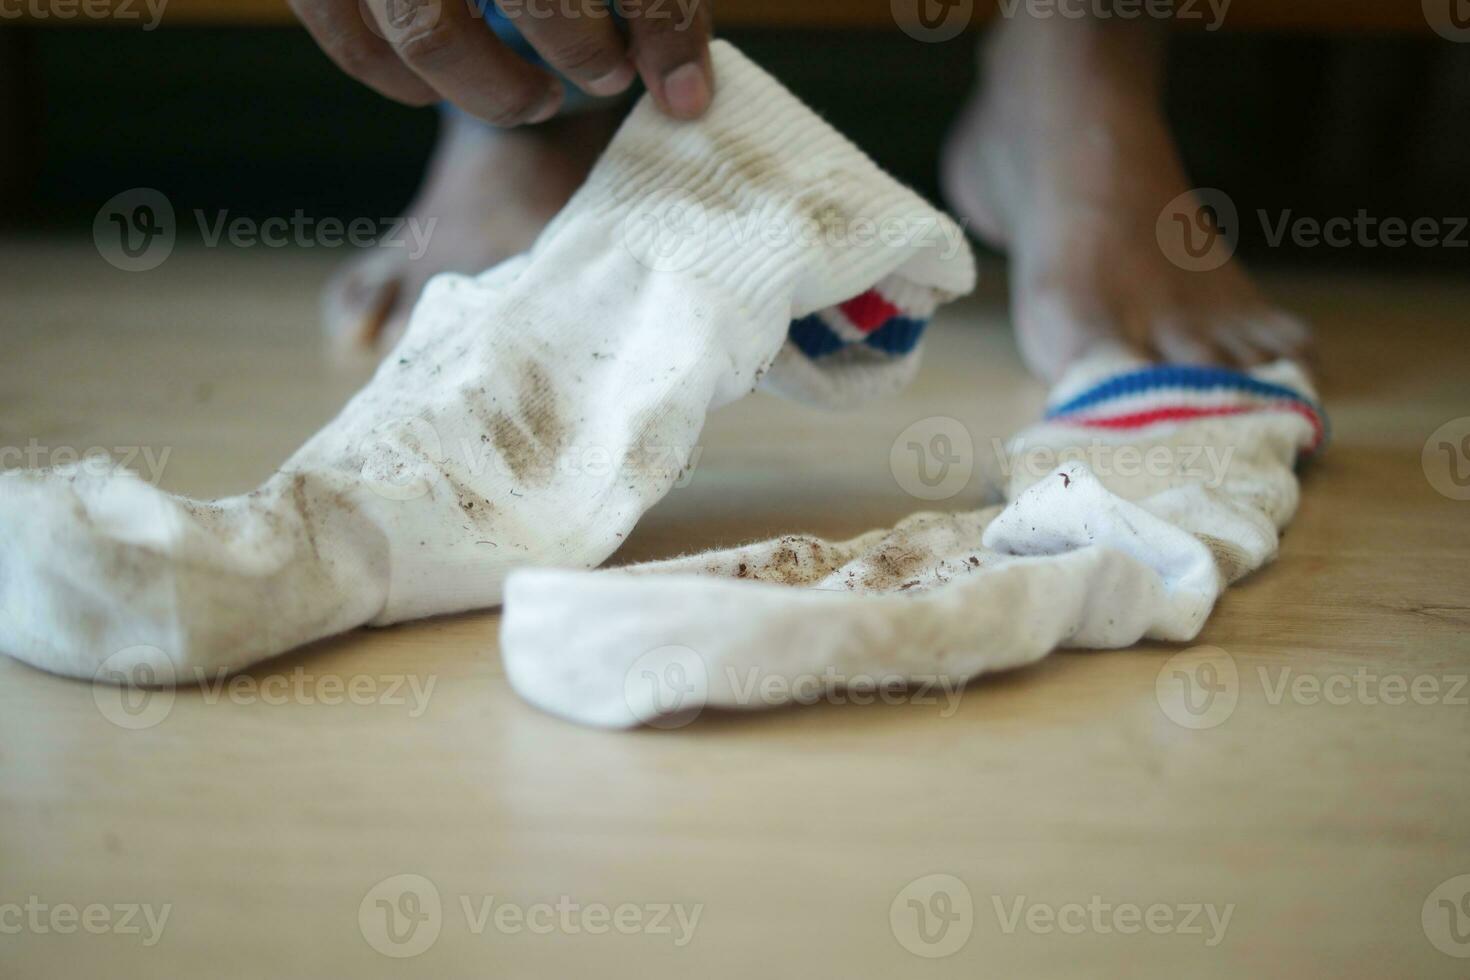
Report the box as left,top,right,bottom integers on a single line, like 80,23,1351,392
367,0,563,126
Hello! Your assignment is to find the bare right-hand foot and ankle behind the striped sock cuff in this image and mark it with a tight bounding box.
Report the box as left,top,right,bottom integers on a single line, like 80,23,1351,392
942,16,1310,379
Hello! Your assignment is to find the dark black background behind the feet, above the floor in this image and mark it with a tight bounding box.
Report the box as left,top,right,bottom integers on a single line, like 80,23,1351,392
0,25,1470,269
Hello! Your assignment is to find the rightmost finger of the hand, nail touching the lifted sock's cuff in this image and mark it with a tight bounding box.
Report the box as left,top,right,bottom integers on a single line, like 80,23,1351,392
617,0,714,119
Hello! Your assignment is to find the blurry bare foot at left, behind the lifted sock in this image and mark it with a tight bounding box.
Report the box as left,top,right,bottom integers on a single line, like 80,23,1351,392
322,110,619,351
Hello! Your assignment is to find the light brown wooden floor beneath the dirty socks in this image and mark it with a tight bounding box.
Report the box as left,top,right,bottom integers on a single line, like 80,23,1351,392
0,242,1470,980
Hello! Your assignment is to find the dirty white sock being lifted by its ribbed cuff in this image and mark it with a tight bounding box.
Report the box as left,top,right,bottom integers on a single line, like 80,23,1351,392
0,43,975,679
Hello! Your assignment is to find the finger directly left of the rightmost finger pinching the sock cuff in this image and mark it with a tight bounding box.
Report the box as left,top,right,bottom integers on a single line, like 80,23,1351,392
501,0,637,96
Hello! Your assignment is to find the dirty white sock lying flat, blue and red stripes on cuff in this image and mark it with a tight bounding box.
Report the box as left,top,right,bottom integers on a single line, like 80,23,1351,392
501,356,1324,727
